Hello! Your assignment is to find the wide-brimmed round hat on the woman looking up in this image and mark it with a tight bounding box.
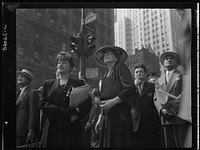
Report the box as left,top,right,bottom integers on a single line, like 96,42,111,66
94,45,128,65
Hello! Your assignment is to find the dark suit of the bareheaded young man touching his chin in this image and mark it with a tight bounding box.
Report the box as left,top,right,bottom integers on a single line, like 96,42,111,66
132,82,161,148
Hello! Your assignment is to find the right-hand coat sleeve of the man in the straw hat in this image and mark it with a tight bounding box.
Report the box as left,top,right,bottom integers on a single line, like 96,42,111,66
28,90,40,131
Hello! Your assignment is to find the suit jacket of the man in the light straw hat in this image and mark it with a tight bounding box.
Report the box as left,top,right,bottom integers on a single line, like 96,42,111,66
16,87,40,136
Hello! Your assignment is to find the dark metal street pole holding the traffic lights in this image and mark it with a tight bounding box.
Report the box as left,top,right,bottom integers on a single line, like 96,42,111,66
79,8,86,78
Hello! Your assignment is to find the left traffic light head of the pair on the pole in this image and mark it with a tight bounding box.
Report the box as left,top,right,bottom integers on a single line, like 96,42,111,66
70,36,82,57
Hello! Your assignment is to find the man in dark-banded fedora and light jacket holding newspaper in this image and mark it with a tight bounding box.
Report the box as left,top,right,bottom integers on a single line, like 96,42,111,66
155,51,191,148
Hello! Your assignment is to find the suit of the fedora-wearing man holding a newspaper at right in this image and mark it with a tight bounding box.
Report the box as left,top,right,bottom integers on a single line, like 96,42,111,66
156,69,189,148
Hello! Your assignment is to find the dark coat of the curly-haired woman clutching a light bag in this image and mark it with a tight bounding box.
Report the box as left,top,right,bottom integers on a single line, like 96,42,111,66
39,78,92,148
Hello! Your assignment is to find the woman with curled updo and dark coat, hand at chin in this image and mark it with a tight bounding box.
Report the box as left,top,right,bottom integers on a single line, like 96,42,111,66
39,51,92,148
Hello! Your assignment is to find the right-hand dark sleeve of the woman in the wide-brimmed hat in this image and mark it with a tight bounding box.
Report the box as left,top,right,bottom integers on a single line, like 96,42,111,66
117,63,136,104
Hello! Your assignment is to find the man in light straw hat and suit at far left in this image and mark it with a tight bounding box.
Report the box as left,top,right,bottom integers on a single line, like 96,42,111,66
16,69,40,146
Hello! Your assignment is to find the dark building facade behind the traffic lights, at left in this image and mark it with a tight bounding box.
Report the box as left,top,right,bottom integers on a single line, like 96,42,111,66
16,9,114,89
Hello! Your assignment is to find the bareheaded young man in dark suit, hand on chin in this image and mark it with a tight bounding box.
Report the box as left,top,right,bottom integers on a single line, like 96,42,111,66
132,64,160,148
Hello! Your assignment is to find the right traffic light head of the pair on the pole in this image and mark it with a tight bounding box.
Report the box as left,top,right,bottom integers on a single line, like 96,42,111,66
85,34,96,57
